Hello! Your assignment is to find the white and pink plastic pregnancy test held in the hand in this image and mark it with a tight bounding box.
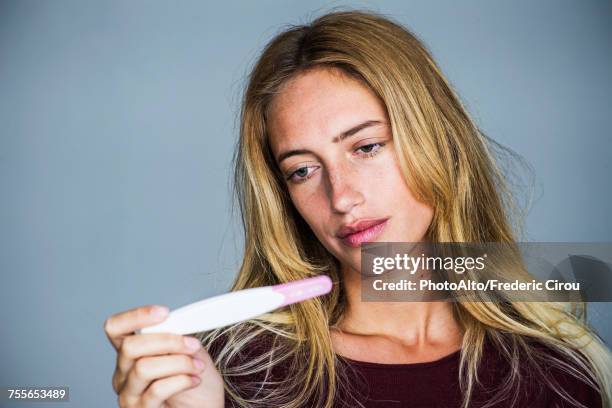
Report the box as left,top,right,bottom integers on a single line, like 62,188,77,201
136,275,332,334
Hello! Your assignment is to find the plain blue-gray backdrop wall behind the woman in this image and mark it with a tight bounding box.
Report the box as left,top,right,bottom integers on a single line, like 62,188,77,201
0,0,612,407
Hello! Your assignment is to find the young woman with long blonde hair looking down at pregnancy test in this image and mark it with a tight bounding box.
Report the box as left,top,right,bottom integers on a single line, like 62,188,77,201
105,11,612,408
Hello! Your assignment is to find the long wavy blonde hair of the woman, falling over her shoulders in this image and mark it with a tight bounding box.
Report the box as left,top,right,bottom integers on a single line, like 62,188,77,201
198,10,612,408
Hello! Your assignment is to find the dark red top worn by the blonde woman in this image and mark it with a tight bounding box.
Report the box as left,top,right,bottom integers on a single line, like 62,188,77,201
209,334,602,408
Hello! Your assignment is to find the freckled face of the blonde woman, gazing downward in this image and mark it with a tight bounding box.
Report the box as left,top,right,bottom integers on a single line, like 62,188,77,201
267,68,433,273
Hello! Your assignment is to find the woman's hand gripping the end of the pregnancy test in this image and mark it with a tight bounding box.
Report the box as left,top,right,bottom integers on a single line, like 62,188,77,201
104,306,224,408
